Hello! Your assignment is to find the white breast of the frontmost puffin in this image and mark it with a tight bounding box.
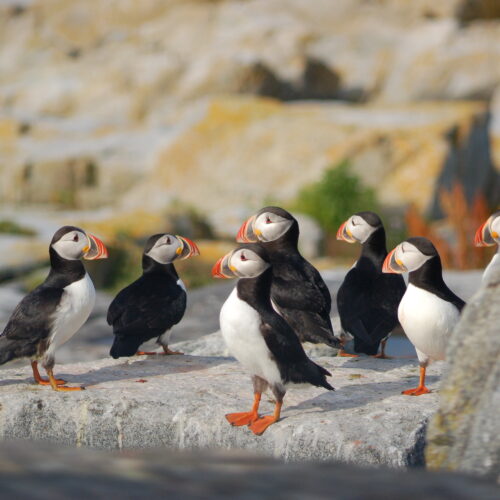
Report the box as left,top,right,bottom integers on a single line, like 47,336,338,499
220,288,282,384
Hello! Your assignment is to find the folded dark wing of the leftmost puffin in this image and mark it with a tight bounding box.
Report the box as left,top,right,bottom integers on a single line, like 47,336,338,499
0,284,64,362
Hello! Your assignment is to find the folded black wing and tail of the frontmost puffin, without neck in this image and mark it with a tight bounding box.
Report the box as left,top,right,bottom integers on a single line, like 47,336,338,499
260,312,333,390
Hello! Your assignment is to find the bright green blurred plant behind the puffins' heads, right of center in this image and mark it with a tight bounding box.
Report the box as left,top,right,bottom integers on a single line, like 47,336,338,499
294,161,378,233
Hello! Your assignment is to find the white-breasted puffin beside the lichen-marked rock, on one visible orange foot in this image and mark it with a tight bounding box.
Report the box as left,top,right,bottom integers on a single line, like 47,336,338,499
382,237,465,396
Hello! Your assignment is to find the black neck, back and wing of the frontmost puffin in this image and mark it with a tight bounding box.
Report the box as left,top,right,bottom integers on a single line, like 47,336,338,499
237,268,333,390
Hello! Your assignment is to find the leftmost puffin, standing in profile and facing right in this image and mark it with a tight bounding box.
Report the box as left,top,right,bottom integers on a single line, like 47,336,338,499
0,226,108,391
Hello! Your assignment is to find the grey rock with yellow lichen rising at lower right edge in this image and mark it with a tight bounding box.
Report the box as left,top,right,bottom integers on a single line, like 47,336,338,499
426,266,500,482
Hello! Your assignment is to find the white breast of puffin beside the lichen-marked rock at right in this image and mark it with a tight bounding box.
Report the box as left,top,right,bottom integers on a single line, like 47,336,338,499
398,283,460,361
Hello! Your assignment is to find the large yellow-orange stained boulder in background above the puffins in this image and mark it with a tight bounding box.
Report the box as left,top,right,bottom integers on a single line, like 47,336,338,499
119,97,498,225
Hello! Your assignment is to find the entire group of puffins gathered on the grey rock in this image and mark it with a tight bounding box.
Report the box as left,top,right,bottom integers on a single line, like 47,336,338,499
0,207,500,435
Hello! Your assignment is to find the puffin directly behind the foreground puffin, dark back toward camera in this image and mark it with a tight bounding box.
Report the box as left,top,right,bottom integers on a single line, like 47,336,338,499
236,206,340,348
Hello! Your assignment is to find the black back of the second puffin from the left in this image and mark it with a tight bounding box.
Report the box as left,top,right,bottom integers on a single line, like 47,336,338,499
107,255,187,358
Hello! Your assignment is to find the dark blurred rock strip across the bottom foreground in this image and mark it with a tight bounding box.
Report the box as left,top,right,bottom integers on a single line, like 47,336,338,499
0,442,498,500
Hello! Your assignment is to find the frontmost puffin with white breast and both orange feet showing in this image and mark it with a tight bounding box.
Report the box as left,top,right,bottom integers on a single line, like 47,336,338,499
212,243,334,435
